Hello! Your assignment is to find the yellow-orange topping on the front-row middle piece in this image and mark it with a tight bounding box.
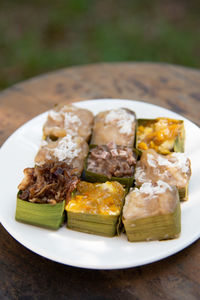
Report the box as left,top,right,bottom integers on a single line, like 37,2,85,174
66,181,125,215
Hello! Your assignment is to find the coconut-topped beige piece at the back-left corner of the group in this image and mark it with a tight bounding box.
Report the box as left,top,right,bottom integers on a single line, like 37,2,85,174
43,104,94,141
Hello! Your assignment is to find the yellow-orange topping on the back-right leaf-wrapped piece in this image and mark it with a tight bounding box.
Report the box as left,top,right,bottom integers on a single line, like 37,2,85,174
137,118,182,154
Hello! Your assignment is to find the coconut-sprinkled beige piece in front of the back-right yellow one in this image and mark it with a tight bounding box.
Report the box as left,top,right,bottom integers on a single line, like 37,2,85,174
135,149,191,200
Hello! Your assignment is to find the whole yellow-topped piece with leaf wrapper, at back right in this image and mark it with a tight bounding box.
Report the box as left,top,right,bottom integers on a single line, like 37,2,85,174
136,118,185,154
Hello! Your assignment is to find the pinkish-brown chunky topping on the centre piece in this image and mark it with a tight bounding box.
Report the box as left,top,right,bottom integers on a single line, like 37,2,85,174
87,143,136,178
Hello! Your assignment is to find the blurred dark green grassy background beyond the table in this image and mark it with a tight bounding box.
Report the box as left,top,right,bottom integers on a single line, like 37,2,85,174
0,0,200,89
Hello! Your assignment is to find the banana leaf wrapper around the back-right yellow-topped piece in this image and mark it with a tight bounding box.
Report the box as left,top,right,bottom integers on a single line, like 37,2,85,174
135,119,185,156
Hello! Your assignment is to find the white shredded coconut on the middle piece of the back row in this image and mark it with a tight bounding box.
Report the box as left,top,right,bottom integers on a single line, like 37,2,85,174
105,108,135,134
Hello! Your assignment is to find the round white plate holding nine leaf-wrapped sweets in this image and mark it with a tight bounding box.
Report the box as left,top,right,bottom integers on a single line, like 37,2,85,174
0,99,200,269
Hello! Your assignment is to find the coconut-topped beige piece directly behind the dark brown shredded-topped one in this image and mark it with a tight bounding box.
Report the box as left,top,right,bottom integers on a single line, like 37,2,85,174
35,135,89,176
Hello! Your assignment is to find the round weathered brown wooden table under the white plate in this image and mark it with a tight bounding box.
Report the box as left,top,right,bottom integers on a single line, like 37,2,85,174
0,63,200,300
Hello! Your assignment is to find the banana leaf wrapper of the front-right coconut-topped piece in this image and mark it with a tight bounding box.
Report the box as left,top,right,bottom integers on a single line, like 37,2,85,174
123,202,181,242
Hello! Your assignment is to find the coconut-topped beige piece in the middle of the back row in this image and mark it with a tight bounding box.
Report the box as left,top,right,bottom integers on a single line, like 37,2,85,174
91,108,136,147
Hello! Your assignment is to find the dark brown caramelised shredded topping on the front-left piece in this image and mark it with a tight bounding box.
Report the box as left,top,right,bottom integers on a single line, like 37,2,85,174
18,162,79,204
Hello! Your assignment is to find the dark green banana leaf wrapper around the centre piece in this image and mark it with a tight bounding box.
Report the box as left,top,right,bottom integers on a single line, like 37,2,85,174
82,145,138,189
